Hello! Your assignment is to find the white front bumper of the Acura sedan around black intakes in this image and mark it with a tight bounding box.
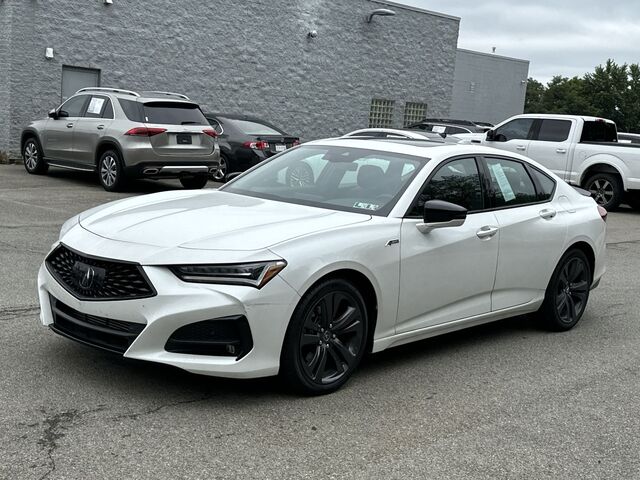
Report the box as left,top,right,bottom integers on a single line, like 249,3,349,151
38,255,299,378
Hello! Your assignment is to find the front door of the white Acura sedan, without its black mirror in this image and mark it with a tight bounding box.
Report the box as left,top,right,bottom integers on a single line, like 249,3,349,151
396,158,499,333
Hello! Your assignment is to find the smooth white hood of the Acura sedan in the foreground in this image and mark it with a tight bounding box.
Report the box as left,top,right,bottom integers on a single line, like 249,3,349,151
80,190,371,251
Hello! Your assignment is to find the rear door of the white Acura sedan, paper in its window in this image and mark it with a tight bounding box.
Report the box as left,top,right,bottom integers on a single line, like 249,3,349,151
484,156,567,311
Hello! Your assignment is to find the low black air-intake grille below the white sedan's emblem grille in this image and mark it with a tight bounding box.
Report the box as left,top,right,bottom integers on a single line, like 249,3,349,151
50,297,145,354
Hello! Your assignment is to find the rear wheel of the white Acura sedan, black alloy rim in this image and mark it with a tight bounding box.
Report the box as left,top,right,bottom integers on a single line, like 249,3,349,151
538,250,591,332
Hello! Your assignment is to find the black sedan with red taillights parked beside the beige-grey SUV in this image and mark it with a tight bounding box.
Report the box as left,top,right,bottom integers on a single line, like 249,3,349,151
205,113,300,182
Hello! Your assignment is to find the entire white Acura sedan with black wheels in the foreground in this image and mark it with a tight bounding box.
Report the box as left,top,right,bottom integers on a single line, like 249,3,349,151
38,139,606,394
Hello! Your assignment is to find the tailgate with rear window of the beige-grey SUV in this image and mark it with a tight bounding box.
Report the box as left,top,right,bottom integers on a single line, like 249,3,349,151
143,101,215,159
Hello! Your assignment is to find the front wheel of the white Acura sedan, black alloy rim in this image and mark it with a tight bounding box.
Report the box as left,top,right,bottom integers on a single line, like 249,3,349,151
280,279,369,395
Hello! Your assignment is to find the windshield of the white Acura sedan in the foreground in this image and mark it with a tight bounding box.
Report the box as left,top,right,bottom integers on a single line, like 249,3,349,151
221,145,429,216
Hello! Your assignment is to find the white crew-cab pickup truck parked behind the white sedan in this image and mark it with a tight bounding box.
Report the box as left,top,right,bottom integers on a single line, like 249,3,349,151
463,114,640,210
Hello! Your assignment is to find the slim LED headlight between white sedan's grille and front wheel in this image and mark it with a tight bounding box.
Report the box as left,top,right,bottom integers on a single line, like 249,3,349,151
169,260,287,288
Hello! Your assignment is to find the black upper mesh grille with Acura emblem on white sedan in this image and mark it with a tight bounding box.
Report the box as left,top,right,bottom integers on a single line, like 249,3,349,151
45,244,156,300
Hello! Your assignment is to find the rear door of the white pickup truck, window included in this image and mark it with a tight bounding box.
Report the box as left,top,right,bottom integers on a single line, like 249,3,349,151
527,118,577,180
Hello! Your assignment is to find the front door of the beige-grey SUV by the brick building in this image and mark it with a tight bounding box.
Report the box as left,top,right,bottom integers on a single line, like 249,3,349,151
43,95,89,162
